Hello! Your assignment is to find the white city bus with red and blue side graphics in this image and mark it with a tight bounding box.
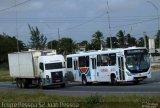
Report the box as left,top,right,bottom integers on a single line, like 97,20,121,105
66,47,151,85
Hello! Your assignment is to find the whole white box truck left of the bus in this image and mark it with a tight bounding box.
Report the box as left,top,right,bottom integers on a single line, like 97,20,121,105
8,51,66,88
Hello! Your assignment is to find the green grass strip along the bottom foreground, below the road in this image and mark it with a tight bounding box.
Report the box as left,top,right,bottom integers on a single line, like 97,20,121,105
0,93,160,108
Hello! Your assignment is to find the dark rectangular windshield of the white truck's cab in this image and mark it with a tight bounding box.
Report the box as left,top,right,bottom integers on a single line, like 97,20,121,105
45,62,63,70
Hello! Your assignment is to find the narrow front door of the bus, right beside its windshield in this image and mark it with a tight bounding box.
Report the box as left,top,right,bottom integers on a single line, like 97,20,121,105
118,57,125,80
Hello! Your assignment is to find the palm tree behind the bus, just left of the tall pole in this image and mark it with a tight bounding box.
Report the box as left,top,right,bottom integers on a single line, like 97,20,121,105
91,31,103,50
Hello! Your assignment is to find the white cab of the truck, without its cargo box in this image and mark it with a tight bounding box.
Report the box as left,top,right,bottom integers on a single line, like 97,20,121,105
38,55,66,87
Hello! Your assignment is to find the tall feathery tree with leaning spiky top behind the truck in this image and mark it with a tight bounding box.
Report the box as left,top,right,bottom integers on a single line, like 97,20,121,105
28,25,47,49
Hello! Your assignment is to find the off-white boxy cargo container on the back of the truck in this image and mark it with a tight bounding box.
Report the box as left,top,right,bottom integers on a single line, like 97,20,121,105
8,52,40,78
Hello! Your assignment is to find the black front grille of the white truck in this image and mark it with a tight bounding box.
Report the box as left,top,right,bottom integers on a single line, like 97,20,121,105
51,71,63,83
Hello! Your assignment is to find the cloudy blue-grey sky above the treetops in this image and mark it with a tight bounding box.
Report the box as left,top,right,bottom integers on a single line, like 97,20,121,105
0,0,160,44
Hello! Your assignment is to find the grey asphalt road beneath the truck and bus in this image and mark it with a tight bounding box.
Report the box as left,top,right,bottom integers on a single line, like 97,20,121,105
0,71,160,96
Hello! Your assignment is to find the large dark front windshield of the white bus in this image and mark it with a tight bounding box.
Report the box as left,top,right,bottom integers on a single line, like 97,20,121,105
125,49,150,73
